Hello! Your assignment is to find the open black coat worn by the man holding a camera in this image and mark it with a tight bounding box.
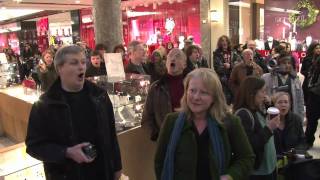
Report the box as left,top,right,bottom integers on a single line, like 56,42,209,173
25,79,122,180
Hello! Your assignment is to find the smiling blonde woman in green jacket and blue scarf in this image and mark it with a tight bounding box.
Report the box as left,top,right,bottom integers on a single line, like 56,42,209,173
155,68,254,180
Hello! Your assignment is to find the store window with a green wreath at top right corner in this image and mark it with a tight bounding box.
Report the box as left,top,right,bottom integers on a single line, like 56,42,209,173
264,0,320,50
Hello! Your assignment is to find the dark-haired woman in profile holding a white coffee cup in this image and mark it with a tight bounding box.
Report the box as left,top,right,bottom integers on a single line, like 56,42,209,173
233,76,280,180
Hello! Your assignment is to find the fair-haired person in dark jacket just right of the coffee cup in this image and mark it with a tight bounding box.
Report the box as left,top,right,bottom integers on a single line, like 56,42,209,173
272,92,305,154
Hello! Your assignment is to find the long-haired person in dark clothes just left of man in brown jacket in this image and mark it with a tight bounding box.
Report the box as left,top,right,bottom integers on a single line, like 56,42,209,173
213,35,240,104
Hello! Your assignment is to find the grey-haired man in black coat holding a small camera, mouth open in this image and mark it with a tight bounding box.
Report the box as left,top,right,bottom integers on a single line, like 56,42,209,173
26,45,122,180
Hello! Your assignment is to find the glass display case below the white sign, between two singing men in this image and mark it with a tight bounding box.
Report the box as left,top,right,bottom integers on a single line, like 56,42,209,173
91,74,150,133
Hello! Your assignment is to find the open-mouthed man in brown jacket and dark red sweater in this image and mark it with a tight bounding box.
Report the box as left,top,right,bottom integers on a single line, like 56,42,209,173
142,48,187,141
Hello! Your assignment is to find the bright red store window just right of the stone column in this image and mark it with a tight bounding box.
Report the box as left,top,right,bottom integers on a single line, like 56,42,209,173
123,0,201,46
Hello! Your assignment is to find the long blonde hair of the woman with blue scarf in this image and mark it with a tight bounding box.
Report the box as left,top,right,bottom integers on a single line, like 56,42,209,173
178,68,229,123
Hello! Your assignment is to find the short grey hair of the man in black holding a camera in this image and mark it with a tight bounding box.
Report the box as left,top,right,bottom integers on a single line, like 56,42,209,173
53,45,84,71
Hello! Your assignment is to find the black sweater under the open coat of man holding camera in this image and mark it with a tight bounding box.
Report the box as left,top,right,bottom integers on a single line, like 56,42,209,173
62,89,105,180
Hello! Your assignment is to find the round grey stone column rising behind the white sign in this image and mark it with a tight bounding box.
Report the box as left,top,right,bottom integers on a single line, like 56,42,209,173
92,0,123,52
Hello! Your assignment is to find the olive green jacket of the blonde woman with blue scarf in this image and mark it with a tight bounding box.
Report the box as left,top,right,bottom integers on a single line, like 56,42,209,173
155,113,255,180
